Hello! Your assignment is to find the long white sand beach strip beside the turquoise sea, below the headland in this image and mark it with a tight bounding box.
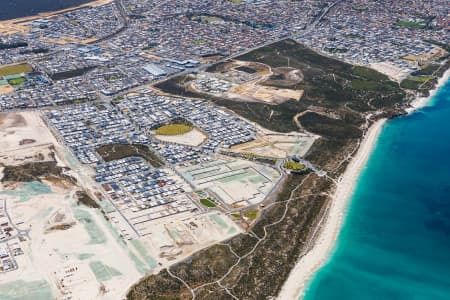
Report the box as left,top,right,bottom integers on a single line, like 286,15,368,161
278,119,386,300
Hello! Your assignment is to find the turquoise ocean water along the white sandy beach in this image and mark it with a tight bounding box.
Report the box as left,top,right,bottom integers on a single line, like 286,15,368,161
304,81,450,300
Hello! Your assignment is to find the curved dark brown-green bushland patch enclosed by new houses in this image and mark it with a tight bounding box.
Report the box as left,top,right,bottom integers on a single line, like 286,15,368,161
97,144,164,168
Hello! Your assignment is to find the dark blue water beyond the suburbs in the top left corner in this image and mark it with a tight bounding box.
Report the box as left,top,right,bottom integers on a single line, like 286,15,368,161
0,0,92,20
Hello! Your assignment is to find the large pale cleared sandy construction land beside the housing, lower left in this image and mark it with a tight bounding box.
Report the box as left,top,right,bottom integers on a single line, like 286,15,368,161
0,112,241,300
